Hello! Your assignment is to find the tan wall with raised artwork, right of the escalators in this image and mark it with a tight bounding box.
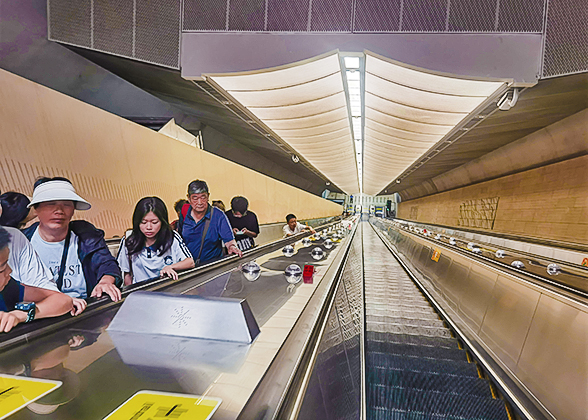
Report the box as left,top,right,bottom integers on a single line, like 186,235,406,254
398,155,588,244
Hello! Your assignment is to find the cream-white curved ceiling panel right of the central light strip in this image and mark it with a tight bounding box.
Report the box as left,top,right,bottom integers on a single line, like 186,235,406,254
363,53,506,195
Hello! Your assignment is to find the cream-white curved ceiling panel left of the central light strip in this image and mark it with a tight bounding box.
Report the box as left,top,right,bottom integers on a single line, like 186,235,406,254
207,52,359,194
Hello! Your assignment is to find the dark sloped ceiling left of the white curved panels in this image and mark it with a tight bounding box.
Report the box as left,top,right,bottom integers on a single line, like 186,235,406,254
67,46,340,195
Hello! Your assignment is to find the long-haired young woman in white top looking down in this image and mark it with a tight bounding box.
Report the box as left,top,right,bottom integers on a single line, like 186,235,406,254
117,197,194,286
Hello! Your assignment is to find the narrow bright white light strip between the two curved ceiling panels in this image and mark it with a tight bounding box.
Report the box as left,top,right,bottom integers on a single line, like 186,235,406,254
343,57,363,194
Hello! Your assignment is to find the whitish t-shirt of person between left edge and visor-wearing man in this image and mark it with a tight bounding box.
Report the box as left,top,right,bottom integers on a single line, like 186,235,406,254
0,200,59,292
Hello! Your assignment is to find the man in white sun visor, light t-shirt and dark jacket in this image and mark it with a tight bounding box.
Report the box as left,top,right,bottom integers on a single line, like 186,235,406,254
23,177,122,312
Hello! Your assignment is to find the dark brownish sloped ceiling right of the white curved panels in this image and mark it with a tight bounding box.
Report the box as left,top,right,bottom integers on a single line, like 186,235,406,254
381,73,588,200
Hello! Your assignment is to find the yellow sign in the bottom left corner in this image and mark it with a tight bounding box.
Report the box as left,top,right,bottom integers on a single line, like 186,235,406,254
0,374,61,420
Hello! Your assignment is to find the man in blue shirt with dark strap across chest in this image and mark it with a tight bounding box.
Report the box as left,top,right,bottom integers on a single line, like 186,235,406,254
180,180,243,265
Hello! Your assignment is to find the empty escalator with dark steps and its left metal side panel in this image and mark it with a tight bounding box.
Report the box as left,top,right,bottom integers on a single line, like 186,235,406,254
298,223,512,420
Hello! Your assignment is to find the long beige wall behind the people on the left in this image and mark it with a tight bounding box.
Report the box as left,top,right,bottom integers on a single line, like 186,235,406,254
0,70,342,237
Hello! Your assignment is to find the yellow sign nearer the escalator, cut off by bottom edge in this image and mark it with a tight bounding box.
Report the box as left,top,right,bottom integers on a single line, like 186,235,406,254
104,391,222,420
